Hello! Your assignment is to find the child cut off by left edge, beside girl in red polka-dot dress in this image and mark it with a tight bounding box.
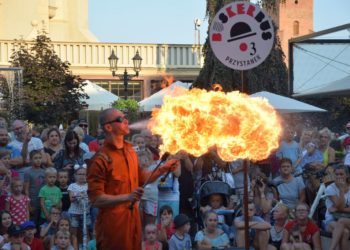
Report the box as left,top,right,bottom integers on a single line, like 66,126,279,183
0,149,19,211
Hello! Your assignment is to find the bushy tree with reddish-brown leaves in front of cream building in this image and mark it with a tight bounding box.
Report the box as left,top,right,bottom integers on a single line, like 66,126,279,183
2,34,88,125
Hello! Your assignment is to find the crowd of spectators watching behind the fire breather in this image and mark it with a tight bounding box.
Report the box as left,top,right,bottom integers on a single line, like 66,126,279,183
0,115,350,250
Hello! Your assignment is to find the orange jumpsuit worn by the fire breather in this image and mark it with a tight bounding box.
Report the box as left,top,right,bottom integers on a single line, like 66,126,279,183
87,142,143,250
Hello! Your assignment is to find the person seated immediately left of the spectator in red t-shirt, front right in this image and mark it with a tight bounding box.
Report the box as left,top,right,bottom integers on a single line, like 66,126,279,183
267,203,289,250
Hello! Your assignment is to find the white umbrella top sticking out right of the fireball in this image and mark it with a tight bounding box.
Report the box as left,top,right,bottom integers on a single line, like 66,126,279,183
250,91,327,113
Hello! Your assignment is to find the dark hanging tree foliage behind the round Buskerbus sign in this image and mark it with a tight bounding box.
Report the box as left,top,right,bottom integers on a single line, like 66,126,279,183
194,0,288,95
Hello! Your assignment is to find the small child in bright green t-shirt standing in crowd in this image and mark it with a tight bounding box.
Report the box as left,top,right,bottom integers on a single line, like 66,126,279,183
39,167,62,220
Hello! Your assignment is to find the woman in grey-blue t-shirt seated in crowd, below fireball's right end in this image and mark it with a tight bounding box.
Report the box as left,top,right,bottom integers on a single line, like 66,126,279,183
273,158,305,209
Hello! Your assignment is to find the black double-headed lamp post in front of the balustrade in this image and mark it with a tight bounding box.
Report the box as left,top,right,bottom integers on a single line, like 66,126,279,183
108,50,142,100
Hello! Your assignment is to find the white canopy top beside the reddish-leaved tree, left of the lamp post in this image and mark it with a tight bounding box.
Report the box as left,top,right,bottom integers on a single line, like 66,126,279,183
80,80,119,110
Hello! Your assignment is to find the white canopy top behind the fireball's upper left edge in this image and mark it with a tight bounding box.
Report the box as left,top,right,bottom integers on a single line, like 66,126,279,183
139,81,191,112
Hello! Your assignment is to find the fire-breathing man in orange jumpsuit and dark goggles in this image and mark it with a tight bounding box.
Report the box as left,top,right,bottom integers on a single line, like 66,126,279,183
87,108,180,250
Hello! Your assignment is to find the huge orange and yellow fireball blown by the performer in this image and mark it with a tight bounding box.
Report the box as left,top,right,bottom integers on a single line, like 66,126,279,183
149,89,281,161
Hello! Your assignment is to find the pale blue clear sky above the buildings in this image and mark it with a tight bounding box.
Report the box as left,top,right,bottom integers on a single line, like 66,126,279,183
88,0,350,44
